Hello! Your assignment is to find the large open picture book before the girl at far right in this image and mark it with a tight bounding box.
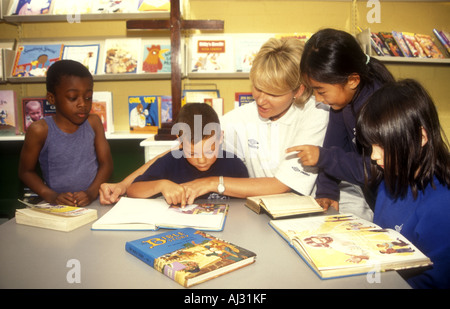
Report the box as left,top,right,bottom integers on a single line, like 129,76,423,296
269,214,432,279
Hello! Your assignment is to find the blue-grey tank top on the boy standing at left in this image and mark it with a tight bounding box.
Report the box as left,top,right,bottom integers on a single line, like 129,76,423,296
39,116,98,193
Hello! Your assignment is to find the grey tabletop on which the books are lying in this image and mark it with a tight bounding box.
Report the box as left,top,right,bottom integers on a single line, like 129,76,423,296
0,199,409,293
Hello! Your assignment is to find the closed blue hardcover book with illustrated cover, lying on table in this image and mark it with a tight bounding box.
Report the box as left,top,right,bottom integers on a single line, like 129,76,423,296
125,228,256,288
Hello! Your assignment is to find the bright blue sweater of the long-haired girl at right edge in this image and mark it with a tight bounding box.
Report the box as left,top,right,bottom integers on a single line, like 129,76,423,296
374,178,450,289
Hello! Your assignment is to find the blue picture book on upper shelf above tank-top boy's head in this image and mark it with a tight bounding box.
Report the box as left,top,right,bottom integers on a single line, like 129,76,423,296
12,44,63,77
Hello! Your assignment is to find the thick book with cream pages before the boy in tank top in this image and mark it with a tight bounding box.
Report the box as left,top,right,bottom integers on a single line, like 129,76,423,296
15,201,97,232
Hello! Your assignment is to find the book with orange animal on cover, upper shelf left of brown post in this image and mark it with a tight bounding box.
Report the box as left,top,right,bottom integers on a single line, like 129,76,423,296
142,41,171,73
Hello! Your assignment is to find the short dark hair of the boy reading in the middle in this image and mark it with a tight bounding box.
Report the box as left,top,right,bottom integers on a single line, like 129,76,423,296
175,103,221,144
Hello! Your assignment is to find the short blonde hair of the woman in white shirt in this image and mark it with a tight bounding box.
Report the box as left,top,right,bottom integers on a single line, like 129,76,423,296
250,38,312,105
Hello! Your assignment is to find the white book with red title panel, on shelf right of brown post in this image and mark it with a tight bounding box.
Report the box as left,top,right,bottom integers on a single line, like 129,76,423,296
190,35,235,73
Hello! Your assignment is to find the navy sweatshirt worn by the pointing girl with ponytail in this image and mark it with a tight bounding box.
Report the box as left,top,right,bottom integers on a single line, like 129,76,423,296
316,83,381,201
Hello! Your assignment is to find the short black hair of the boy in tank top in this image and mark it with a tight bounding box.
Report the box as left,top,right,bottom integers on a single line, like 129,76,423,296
46,60,93,93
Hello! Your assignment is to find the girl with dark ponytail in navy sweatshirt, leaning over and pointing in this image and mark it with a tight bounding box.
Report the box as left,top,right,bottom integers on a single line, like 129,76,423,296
287,29,394,220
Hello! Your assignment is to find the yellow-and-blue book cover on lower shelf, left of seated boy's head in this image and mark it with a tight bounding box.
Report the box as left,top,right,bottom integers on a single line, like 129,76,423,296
128,95,160,134
